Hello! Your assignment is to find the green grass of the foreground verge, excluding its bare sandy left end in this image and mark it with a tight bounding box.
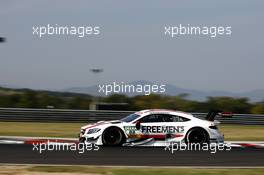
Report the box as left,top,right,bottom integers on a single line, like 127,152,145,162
27,166,264,175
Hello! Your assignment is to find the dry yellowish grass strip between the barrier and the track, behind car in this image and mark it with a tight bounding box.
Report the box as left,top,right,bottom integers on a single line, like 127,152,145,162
0,122,264,141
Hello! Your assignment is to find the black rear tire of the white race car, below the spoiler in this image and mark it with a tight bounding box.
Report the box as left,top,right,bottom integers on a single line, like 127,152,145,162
185,127,210,144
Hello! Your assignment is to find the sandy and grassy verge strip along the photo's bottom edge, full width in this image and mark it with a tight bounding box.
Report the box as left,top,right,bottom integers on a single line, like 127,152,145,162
0,165,264,175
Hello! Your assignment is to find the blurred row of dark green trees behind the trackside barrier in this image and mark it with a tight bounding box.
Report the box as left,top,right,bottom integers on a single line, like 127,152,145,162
0,88,264,114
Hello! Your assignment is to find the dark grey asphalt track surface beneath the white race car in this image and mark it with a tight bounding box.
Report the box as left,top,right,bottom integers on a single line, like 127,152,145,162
0,144,264,166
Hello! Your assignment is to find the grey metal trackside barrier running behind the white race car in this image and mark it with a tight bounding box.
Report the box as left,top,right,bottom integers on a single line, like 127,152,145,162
0,108,264,125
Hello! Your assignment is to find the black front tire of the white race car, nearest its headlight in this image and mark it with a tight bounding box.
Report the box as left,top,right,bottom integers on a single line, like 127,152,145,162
102,127,125,146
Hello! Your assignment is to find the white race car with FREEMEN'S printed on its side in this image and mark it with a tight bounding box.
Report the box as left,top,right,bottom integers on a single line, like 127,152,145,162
79,109,229,146
